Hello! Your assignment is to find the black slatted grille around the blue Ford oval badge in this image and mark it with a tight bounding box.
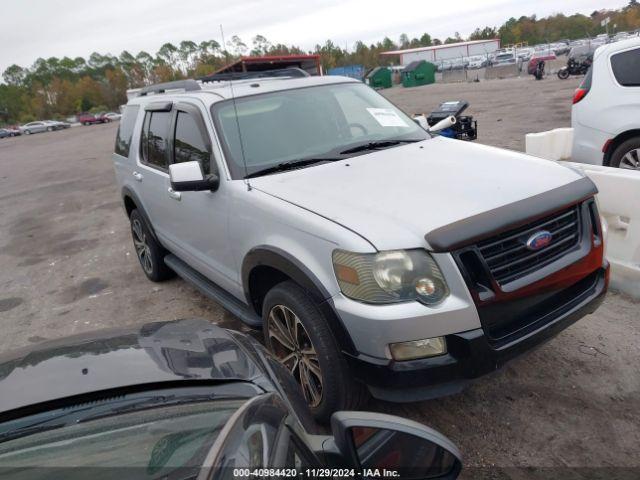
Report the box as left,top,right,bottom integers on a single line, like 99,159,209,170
477,205,580,285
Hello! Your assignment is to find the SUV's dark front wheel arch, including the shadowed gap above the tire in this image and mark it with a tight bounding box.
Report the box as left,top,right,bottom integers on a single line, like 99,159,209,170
241,245,356,354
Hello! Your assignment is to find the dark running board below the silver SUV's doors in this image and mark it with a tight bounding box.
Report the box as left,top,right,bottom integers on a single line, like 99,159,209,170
164,254,262,328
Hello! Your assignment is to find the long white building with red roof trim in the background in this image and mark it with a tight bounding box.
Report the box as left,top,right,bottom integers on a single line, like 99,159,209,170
380,38,500,65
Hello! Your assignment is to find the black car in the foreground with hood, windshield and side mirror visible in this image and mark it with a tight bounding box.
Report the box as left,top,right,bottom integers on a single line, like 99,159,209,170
0,320,462,480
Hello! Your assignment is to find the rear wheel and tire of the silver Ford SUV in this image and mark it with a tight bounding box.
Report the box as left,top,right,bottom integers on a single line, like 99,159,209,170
129,209,175,282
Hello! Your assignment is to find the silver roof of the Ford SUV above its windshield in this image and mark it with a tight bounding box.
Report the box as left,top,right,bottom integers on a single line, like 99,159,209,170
128,75,361,105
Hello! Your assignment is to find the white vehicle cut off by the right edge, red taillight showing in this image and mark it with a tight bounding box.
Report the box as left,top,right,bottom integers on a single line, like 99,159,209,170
571,38,640,170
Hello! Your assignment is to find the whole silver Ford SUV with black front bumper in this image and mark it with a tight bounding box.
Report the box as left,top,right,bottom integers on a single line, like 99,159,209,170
113,77,608,419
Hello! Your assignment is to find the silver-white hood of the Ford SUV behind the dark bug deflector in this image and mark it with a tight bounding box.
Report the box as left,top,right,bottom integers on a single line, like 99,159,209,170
251,137,581,250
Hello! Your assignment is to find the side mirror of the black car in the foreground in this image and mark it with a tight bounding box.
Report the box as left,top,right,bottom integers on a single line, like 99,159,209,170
325,412,462,480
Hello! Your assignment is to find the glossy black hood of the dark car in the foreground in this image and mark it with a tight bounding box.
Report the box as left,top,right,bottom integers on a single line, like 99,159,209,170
0,320,264,412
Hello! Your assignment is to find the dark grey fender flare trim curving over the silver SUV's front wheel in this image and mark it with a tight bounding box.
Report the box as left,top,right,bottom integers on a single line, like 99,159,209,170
241,245,357,354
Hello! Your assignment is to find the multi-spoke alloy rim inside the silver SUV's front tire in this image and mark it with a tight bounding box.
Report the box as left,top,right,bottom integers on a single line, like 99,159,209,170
267,305,323,407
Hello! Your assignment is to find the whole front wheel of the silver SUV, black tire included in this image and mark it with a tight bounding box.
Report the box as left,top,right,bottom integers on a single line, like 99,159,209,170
262,280,367,423
